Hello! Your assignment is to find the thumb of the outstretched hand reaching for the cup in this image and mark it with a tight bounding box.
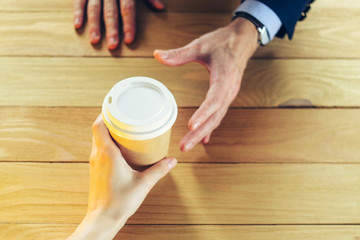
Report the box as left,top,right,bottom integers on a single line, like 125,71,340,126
154,44,198,67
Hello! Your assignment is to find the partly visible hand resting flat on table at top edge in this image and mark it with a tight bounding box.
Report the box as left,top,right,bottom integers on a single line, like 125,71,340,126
74,0,165,50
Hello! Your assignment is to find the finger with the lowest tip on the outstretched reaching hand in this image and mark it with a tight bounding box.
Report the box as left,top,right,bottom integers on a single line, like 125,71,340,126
180,108,227,152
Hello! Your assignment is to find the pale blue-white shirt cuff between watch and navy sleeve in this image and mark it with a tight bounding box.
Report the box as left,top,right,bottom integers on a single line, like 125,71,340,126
234,0,282,40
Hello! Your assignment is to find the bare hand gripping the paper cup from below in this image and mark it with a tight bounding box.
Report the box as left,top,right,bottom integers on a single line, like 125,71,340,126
69,115,177,240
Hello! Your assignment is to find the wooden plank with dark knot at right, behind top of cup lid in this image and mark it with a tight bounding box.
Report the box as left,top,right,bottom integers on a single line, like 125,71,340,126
0,57,360,107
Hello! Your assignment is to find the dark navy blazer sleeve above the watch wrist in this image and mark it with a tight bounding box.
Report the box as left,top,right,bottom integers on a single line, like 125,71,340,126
258,0,313,39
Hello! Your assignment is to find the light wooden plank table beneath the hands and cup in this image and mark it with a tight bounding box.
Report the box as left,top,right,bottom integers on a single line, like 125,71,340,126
0,0,360,240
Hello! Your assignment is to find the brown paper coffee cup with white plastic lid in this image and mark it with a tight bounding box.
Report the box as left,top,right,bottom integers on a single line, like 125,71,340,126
102,77,177,170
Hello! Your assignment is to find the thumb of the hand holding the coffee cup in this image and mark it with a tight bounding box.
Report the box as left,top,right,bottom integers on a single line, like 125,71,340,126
142,158,177,188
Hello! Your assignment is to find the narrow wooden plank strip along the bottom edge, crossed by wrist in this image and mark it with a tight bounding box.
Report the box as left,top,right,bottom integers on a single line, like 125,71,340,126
0,224,360,240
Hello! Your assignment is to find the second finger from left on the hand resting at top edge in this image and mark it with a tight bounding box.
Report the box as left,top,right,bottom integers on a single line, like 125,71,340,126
88,0,101,44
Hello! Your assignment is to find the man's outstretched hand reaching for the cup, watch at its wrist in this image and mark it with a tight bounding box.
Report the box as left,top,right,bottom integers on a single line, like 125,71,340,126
154,18,258,151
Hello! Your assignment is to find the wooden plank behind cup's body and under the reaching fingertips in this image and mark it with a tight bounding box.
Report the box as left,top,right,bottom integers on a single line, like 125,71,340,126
0,107,360,163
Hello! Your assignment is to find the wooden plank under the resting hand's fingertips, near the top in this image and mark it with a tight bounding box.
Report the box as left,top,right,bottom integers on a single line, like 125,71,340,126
0,9,360,59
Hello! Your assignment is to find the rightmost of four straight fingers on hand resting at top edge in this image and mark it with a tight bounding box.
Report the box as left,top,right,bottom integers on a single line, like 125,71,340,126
120,0,135,44
